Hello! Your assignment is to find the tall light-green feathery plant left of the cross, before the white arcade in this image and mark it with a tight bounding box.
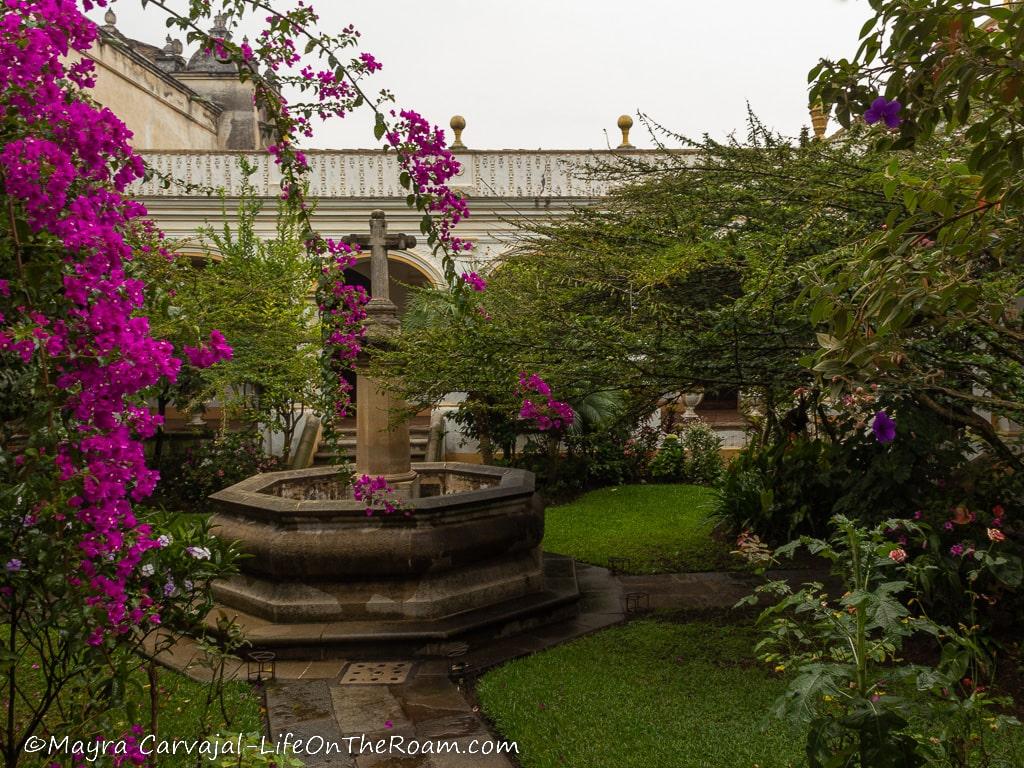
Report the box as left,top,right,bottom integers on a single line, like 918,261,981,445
162,159,319,462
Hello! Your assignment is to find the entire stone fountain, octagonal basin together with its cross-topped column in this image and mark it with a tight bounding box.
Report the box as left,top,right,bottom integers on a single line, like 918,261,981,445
211,211,580,657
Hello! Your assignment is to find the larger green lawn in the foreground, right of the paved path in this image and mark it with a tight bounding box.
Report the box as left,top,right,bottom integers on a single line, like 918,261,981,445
477,621,803,768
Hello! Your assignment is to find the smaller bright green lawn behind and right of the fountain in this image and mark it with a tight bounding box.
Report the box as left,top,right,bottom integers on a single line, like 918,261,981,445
544,485,739,573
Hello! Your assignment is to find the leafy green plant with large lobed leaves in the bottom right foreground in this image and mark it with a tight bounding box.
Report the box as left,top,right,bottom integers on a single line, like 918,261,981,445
739,516,1020,768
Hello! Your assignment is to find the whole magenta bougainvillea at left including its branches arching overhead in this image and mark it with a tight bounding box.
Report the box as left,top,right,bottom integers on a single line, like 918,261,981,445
0,0,495,766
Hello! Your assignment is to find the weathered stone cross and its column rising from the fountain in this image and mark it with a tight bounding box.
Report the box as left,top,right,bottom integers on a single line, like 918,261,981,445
345,210,418,496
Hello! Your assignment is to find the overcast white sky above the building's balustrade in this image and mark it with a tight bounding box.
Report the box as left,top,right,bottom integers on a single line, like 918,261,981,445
92,0,869,150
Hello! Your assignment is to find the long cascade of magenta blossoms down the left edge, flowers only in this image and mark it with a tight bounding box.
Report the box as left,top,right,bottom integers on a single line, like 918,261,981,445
0,0,229,645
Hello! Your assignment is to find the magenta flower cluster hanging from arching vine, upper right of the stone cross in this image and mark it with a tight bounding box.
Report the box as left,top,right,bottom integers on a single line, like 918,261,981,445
387,110,470,254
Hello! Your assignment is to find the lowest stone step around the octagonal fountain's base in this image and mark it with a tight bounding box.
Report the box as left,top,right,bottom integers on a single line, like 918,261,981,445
208,554,580,658
